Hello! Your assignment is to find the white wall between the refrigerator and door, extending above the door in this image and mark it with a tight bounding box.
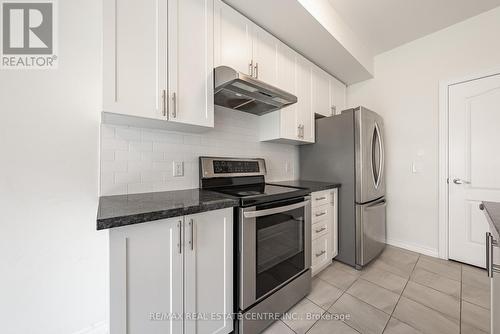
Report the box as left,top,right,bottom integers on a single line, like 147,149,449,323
348,7,500,254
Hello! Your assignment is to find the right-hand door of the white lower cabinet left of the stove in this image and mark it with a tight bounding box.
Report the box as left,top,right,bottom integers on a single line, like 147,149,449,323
185,208,233,334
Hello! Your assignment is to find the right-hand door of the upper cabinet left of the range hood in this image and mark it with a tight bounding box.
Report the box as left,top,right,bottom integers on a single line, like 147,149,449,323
167,0,214,127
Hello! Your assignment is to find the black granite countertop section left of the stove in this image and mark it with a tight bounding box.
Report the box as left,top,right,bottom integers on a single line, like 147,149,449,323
97,189,239,230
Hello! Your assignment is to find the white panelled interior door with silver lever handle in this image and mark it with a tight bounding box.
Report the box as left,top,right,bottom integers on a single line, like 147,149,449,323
448,75,500,267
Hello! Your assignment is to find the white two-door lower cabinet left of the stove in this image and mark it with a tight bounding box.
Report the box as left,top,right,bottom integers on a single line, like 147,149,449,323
109,208,233,334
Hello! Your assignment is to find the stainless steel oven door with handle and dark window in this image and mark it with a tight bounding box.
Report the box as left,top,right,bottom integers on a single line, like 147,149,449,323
239,197,311,310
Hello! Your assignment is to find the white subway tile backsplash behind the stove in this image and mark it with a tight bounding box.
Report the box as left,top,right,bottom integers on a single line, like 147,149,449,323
101,108,298,195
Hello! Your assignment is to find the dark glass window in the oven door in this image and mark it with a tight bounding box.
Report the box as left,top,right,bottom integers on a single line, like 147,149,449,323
256,207,305,298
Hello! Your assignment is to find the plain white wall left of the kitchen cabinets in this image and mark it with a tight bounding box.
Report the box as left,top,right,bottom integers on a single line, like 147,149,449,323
0,0,107,334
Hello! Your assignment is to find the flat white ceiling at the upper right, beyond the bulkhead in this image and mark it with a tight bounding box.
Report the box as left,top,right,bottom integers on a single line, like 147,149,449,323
329,0,500,54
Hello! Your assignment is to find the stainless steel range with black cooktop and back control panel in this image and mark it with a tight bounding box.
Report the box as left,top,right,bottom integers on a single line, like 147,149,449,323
200,157,311,334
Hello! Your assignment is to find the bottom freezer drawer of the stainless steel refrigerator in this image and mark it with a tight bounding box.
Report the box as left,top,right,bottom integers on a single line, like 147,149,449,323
356,198,387,267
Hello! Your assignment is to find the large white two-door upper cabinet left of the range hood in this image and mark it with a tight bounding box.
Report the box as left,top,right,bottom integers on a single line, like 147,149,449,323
103,0,214,131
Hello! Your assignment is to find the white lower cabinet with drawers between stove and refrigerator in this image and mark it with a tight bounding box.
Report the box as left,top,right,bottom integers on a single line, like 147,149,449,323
311,189,338,276
